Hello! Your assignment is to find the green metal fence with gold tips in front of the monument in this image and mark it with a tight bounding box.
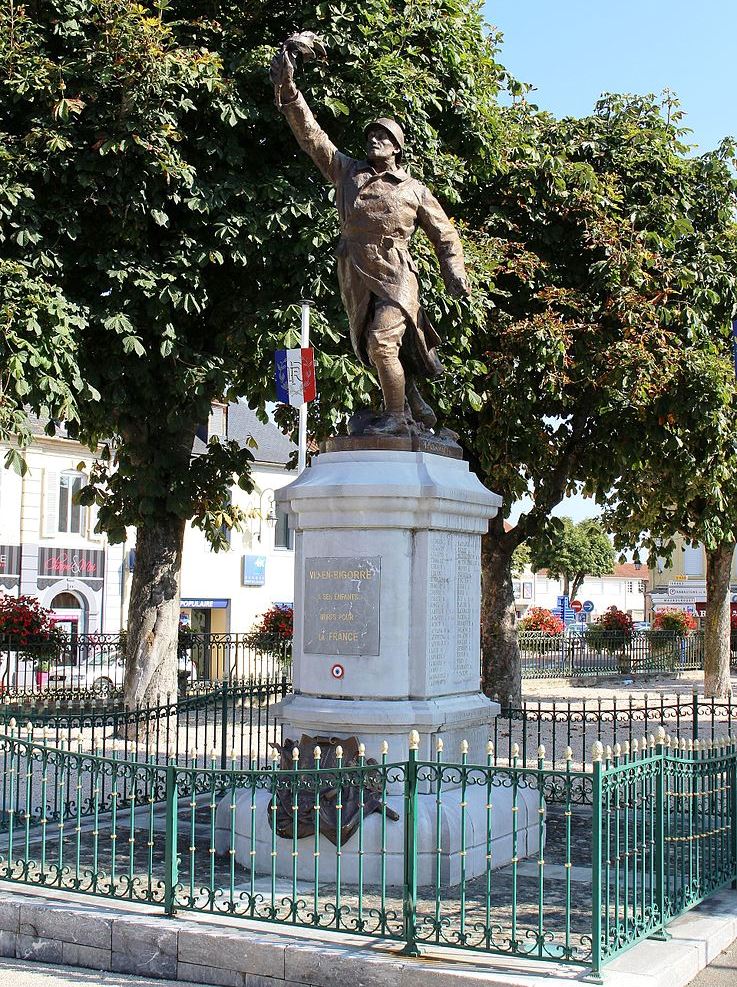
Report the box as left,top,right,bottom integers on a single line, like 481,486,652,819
0,729,737,974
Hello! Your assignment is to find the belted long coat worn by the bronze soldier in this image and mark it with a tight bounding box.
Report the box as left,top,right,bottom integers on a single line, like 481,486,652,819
281,93,465,377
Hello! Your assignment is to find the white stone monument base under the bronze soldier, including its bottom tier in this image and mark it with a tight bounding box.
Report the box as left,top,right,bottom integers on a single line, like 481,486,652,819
216,439,539,885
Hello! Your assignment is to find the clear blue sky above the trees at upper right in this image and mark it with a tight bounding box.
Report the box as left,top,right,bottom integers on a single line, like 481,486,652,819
484,0,737,151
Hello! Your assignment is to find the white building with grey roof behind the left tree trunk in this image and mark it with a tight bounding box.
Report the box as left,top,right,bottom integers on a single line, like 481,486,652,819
0,404,295,634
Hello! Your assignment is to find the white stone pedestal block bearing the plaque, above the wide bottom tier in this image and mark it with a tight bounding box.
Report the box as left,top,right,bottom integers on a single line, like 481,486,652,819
277,449,501,761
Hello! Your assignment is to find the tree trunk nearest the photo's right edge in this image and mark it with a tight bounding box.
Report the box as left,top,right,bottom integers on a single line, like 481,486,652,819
704,541,735,696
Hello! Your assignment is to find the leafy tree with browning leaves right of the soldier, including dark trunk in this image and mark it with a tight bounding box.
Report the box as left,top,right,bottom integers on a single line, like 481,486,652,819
438,96,737,701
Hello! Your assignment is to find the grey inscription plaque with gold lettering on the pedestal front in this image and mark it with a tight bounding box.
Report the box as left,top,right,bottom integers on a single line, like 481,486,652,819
302,556,381,656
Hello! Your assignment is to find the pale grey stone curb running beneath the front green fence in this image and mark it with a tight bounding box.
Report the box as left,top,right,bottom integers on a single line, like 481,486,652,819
0,885,737,987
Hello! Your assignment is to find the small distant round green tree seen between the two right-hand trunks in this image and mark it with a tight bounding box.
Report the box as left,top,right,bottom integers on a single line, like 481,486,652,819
532,517,614,599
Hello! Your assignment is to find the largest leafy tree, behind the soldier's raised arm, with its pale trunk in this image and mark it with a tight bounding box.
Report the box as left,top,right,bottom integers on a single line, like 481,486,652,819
0,0,511,702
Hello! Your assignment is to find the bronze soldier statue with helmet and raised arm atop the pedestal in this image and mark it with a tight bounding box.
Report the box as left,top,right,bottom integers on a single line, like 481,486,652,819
271,32,470,438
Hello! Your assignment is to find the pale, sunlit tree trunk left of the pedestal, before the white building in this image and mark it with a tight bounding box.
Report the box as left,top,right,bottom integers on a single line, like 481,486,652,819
125,517,185,706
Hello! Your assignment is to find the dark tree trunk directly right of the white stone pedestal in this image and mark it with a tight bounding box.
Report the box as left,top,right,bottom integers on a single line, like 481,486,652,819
481,515,522,706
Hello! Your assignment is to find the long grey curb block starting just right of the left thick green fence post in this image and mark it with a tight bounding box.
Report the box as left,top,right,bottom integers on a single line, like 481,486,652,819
177,925,285,980
